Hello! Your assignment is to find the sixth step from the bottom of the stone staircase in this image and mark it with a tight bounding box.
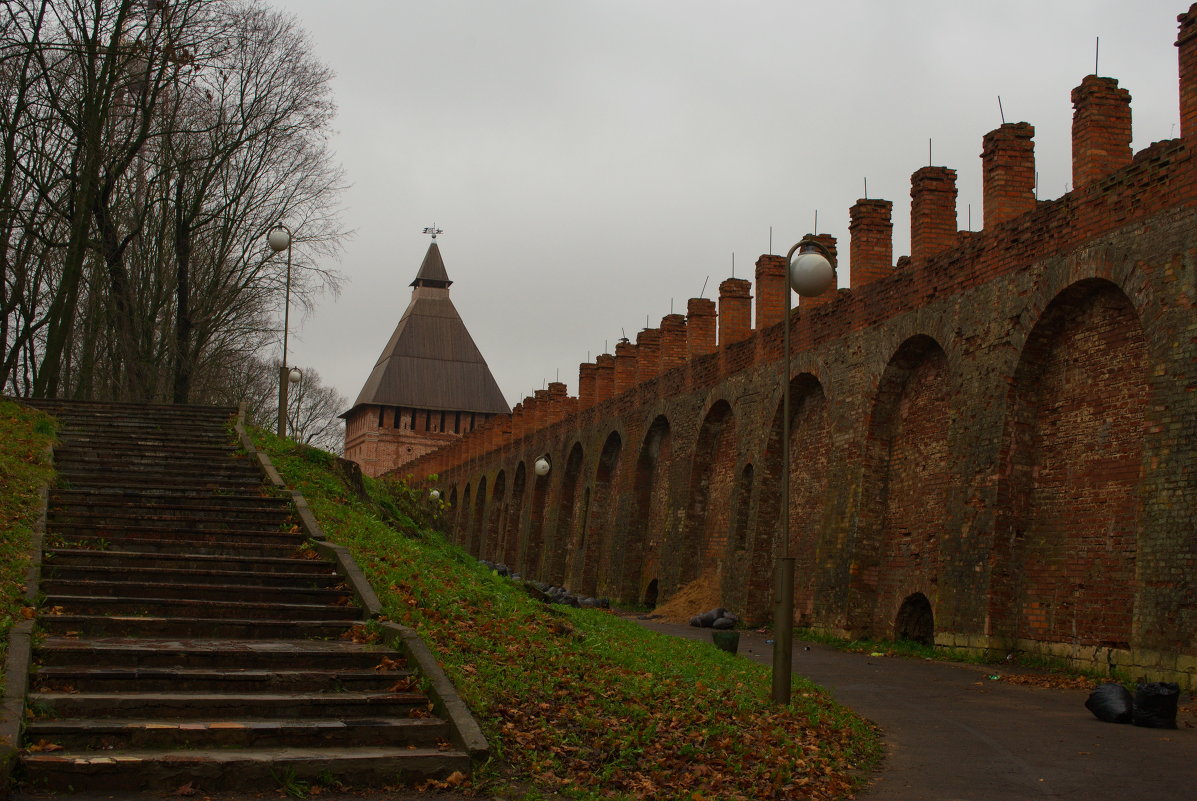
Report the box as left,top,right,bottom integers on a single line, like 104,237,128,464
38,607,358,639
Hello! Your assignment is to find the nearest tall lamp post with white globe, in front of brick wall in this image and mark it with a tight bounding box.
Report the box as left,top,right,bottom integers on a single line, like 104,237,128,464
773,236,836,704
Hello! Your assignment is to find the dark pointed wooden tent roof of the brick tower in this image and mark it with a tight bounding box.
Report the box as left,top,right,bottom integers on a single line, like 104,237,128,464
341,239,511,417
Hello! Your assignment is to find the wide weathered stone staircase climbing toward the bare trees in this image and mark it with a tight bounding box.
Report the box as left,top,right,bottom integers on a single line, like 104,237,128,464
22,401,470,791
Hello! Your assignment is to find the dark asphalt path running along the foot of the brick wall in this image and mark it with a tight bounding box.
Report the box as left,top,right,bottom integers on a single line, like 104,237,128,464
642,621,1197,801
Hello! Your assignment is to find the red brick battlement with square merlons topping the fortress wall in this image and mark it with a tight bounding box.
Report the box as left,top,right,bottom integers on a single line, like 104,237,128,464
403,10,1197,477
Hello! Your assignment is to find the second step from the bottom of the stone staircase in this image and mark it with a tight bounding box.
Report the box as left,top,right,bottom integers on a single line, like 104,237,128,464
26,716,449,753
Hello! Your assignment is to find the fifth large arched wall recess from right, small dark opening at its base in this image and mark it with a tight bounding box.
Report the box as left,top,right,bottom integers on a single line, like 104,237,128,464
619,415,673,606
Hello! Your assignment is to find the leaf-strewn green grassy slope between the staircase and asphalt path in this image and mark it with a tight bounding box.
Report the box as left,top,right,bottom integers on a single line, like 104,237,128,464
256,432,880,801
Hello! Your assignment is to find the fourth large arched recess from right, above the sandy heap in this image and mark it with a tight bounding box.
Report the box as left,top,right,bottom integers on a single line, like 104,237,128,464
679,400,736,587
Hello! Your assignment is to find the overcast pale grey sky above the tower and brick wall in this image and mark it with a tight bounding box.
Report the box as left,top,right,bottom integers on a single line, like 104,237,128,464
271,0,1186,406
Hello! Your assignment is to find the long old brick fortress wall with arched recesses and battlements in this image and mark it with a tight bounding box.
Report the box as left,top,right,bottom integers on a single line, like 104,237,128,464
405,5,1197,687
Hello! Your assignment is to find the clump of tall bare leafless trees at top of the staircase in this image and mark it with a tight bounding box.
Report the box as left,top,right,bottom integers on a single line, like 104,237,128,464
0,0,345,402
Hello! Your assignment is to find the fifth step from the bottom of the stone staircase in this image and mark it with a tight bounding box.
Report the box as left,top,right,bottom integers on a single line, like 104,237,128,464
35,637,407,675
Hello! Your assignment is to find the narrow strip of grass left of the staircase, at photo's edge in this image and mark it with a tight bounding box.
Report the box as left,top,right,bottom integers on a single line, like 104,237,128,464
0,400,54,679
